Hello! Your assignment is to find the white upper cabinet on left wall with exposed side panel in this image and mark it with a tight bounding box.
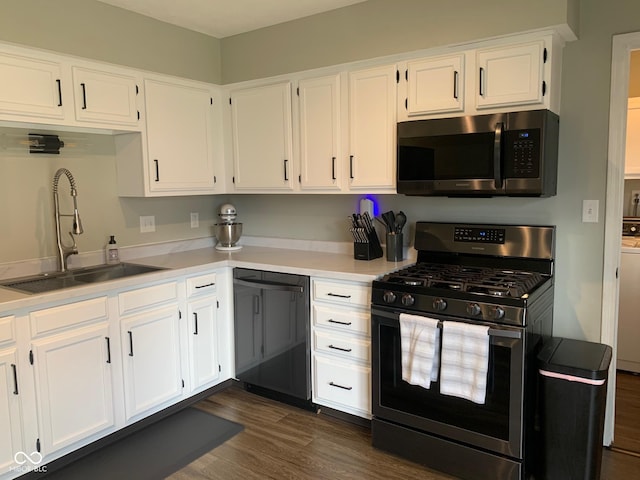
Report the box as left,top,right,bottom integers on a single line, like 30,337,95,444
115,77,224,197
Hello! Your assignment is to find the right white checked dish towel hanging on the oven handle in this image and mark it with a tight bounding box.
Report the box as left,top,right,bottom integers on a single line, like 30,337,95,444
440,322,489,405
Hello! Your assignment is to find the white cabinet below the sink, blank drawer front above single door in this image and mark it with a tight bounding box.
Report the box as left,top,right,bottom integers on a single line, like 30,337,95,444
29,297,115,456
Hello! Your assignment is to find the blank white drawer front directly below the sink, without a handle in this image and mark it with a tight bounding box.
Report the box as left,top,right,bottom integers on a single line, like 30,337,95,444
29,297,109,337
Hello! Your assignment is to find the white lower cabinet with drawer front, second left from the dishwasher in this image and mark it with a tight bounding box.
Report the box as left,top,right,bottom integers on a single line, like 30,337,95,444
118,282,183,422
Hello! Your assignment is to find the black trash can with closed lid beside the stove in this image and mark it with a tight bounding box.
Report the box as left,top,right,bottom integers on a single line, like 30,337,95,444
538,338,612,480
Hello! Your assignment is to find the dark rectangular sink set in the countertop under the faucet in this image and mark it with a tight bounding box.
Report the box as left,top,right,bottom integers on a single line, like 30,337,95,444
0,263,164,293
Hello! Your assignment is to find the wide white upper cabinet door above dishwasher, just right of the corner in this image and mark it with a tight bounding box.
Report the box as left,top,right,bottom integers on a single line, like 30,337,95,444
231,82,293,191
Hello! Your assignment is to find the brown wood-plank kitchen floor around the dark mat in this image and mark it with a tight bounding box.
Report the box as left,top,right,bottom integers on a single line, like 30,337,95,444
169,386,640,480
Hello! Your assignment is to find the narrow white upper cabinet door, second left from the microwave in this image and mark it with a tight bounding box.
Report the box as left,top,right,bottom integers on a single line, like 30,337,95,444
298,75,342,190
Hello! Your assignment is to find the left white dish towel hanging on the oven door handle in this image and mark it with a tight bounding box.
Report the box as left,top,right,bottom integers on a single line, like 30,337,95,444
400,313,440,388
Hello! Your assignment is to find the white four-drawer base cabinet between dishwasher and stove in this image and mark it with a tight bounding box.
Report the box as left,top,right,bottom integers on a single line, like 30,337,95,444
311,278,371,418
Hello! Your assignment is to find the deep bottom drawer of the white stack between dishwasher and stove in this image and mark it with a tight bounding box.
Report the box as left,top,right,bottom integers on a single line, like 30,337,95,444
313,355,371,413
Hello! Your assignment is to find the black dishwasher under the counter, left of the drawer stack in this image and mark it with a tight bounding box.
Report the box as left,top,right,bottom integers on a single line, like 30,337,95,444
233,268,312,408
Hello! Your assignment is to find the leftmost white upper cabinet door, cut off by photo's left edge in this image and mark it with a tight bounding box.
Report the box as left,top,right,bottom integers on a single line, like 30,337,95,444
0,49,64,119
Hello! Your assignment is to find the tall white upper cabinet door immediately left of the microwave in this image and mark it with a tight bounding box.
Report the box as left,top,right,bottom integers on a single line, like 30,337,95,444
349,65,396,193
